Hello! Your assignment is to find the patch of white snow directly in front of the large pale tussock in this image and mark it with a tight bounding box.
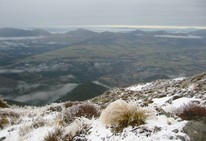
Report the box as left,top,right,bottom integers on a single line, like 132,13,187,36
86,116,188,141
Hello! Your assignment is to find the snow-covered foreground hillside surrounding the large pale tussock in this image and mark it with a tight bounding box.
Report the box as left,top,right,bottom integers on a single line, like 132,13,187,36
0,73,206,141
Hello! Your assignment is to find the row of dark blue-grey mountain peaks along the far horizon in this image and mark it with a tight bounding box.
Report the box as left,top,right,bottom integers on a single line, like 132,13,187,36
0,28,206,38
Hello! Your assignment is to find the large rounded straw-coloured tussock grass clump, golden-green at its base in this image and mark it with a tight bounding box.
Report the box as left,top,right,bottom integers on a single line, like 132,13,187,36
100,100,149,131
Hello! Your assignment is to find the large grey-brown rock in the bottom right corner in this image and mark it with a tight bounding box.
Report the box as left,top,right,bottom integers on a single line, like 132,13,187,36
183,117,206,141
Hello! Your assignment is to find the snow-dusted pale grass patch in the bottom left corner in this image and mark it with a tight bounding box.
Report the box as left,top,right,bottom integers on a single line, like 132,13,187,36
0,103,58,141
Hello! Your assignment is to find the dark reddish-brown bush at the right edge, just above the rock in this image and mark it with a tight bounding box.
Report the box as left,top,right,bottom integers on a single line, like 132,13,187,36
176,103,206,120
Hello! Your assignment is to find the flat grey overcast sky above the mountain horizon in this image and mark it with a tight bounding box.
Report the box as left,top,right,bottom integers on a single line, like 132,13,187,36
0,0,206,27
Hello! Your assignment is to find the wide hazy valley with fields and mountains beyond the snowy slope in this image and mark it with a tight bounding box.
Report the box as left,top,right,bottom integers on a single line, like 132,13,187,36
0,29,206,104
